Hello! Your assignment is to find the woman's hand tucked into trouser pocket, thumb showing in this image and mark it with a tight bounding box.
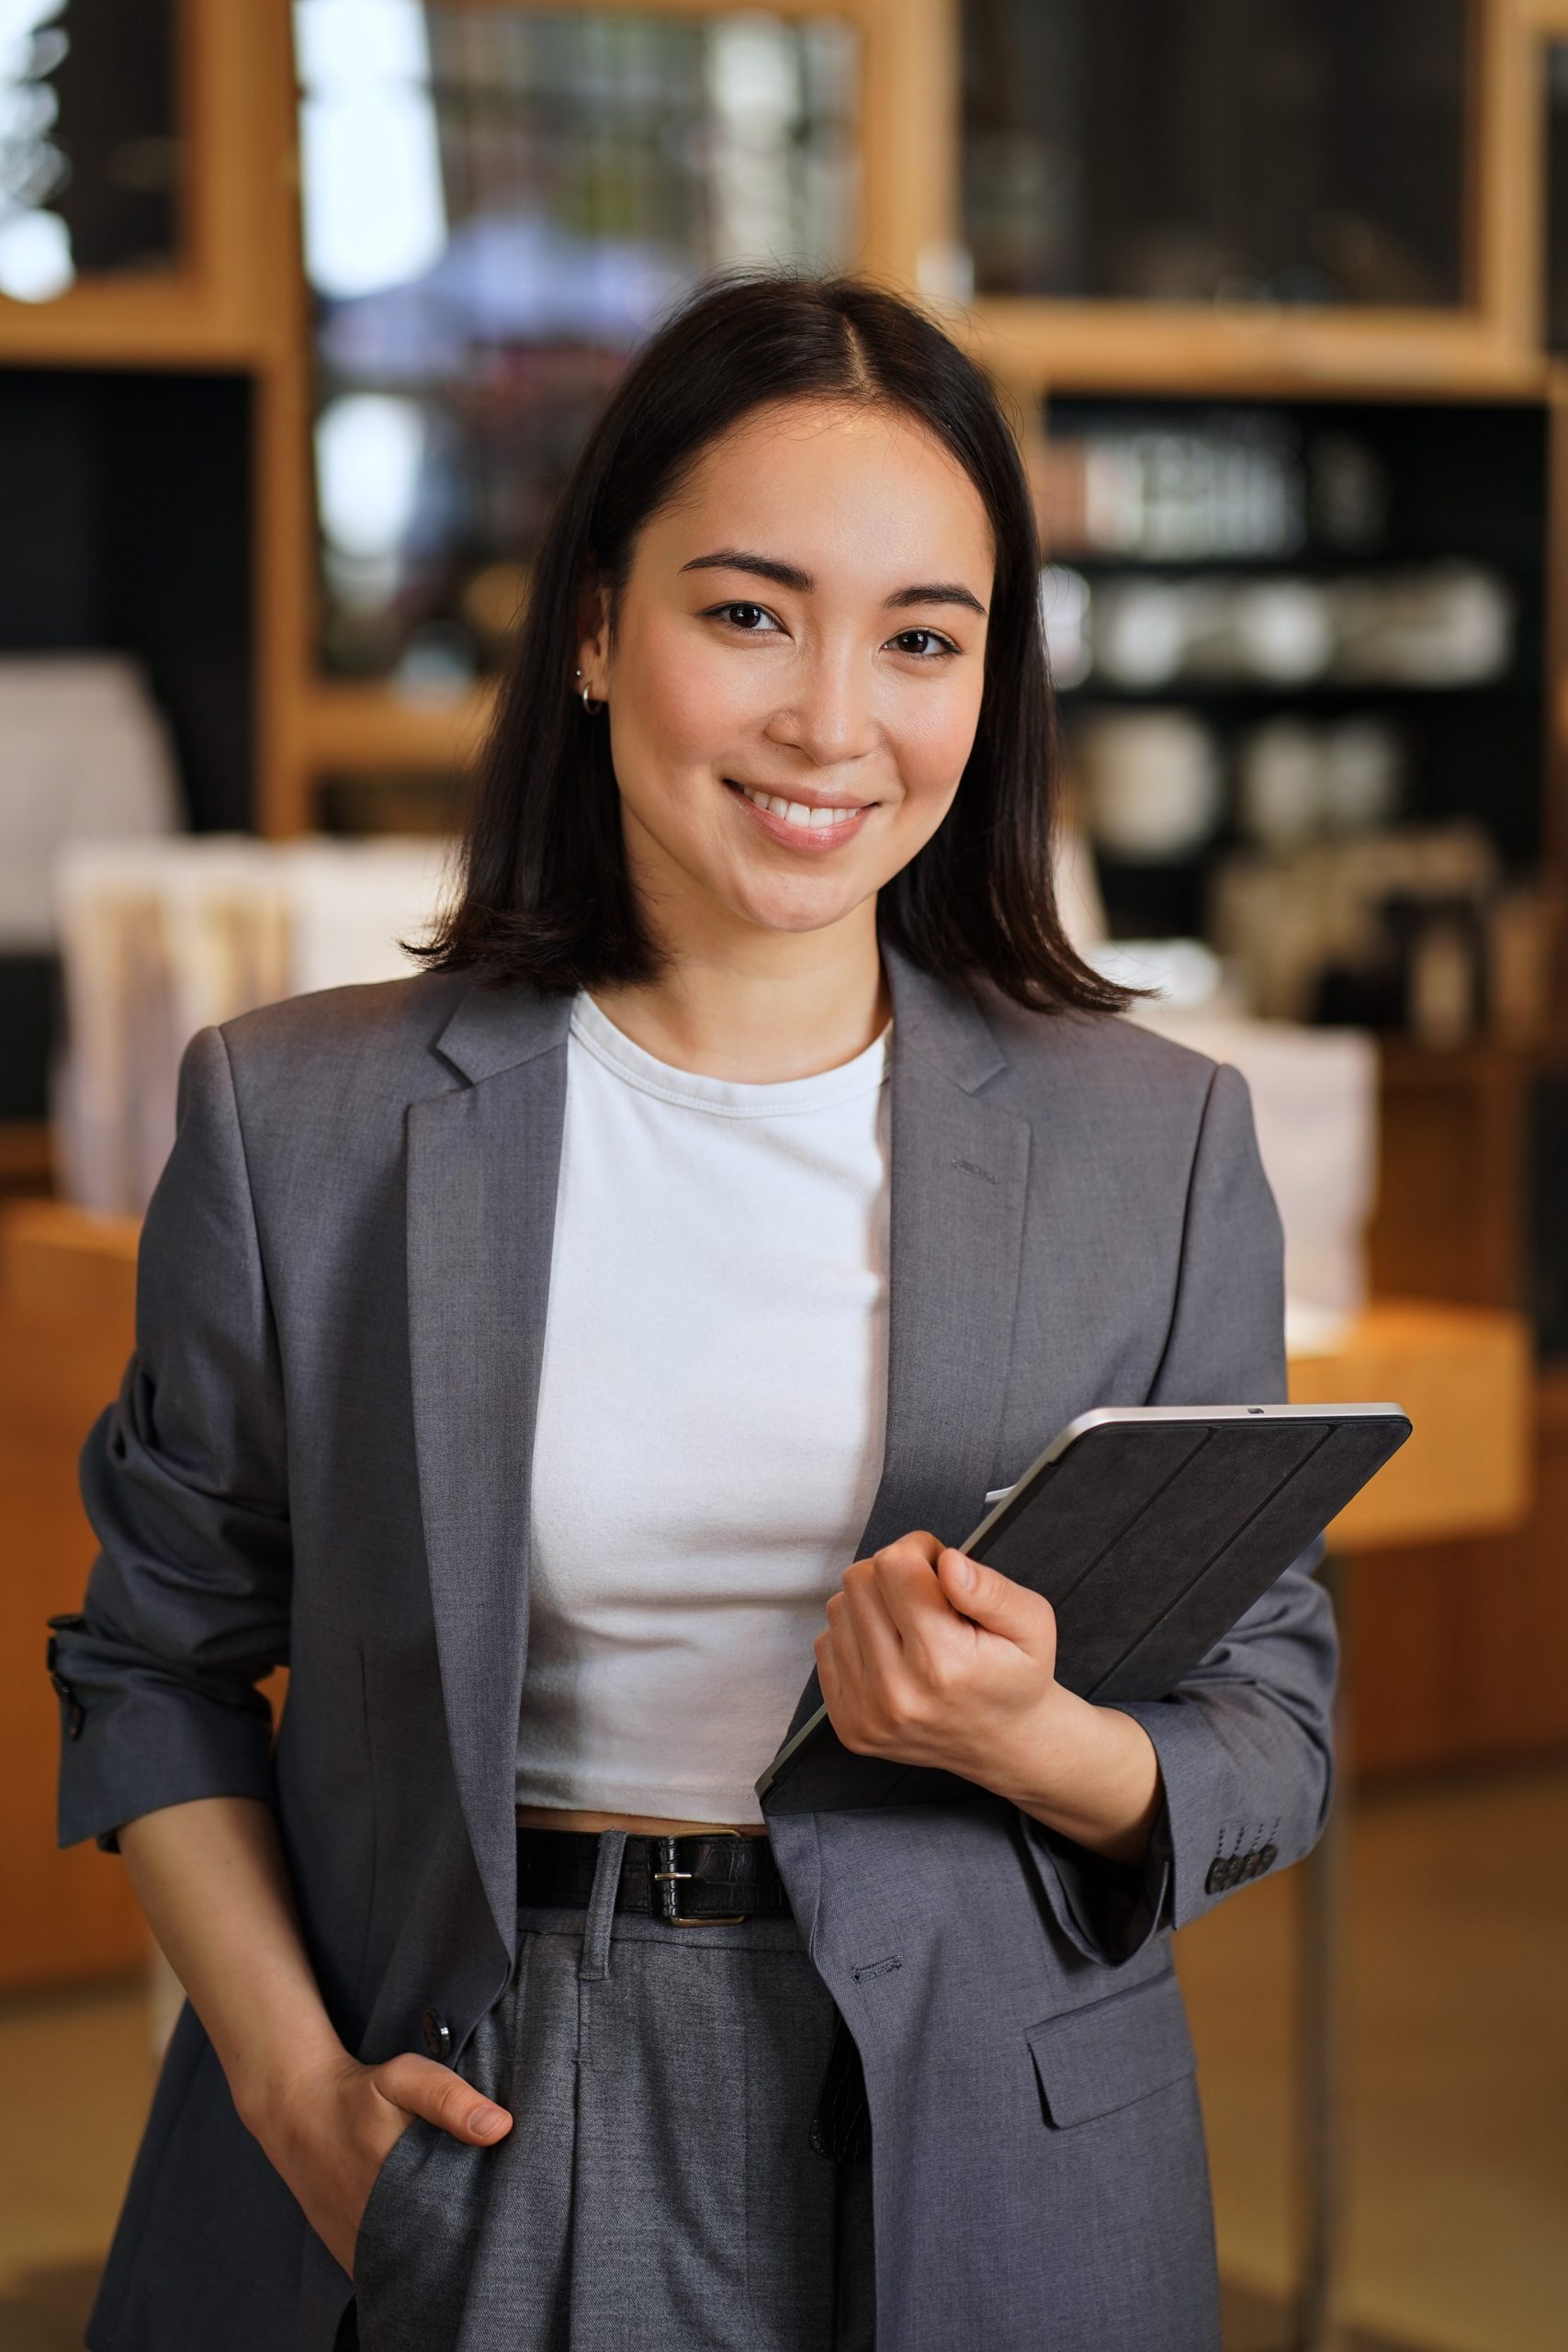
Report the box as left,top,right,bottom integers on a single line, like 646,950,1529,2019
247,2051,513,2277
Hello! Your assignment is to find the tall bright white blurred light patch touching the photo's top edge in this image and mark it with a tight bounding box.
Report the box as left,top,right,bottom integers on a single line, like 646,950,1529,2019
294,0,446,299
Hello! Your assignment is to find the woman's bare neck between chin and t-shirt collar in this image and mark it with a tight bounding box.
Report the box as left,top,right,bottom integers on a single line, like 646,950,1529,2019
594,903,888,1087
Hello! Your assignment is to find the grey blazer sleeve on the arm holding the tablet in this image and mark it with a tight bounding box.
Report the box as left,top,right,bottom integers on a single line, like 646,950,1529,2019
1025,1068,1337,1962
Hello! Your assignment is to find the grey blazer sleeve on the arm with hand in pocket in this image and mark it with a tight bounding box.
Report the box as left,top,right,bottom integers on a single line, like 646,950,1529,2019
50,1030,291,1849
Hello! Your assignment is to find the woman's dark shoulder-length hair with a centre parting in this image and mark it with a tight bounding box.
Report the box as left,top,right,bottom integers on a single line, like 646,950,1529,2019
419,273,1126,1012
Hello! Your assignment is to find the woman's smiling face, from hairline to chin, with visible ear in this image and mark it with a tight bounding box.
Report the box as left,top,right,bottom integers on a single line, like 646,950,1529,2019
579,400,992,948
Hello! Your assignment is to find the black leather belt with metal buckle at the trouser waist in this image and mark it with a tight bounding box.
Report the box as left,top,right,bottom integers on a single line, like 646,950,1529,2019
517,1826,790,1927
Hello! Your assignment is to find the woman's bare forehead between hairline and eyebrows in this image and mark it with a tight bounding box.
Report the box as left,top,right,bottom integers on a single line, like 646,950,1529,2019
644,400,995,593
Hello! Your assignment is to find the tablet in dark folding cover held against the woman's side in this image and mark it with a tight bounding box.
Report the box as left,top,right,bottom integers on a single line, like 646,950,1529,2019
757,1404,1411,1814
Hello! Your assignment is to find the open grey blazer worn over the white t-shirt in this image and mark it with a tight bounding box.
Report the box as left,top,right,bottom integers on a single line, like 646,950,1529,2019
54,955,1336,2352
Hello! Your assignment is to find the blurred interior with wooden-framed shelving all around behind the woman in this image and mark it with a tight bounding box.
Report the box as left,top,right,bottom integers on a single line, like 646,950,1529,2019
0,0,1568,2352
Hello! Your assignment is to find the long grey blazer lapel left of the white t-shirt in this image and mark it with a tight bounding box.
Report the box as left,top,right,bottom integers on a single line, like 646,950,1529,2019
409,988,571,1950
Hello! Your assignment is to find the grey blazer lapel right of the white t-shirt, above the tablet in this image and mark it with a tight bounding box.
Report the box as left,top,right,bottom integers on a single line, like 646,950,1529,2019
790,948,1030,1731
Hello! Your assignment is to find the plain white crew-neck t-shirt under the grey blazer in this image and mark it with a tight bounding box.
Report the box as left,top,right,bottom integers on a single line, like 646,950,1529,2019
517,995,888,1823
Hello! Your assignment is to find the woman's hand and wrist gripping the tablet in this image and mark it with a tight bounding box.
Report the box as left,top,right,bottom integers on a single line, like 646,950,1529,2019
816,1532,1159,1860
